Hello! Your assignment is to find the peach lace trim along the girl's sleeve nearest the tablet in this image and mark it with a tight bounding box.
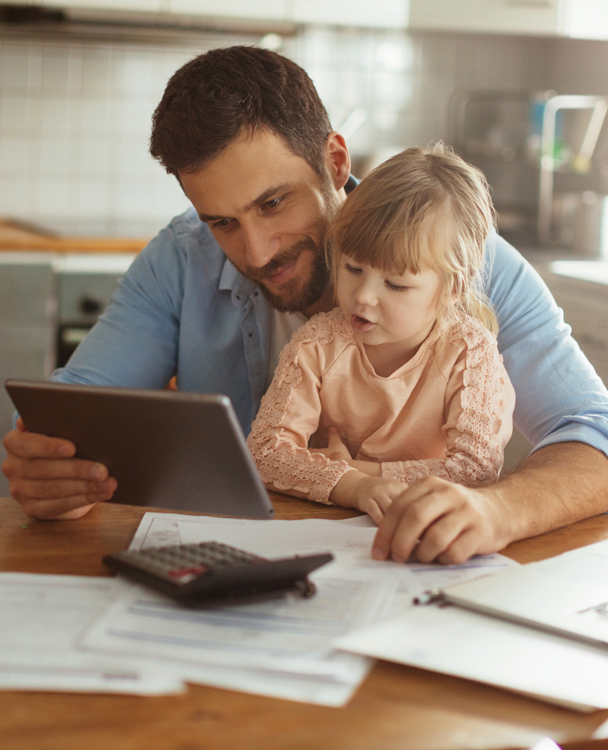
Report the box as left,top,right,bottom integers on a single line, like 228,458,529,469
247,309,352,504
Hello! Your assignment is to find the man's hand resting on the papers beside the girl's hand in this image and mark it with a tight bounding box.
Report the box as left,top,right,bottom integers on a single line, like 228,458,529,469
372,477,510,564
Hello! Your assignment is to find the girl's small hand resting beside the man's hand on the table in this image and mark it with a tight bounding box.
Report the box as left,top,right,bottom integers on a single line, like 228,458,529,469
329,471,404,525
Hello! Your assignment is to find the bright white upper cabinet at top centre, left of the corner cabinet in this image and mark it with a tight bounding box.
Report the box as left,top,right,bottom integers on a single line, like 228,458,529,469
291,0,409,28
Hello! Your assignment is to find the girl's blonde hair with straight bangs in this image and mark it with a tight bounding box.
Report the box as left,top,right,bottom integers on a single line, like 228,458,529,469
327,143,498,333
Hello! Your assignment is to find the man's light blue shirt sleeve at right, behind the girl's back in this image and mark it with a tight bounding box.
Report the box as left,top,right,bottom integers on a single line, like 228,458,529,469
487,234,608,464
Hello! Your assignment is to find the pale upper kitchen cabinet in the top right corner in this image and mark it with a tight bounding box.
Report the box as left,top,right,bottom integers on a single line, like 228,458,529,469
410,0,608,39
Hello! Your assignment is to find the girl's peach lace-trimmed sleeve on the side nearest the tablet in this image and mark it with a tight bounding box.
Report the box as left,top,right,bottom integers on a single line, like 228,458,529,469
247,313,352,504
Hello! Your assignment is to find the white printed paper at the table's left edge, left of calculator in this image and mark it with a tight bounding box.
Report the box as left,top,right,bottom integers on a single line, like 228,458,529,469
0,573,184,695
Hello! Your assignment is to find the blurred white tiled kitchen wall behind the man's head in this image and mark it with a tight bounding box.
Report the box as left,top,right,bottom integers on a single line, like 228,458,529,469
0,27,551,236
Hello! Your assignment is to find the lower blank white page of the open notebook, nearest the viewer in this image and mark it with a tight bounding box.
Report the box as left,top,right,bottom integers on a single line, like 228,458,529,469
335,605,608,710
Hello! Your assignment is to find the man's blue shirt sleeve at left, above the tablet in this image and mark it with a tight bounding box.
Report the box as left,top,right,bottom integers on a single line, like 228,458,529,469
51,222,185,388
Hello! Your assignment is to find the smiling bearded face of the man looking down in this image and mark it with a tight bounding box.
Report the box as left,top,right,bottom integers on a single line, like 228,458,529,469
179,130,343,311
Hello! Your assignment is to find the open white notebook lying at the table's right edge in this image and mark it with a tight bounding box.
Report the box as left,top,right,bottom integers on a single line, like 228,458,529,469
336,541,608,710
